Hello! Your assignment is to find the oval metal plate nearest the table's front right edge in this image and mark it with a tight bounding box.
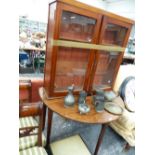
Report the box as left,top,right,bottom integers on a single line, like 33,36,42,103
104,102,123,115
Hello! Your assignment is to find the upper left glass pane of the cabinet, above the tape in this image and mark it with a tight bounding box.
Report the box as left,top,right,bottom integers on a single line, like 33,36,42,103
59,11,96,42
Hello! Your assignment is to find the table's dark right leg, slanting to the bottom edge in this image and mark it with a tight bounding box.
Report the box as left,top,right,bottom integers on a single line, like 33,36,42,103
94,124,107,155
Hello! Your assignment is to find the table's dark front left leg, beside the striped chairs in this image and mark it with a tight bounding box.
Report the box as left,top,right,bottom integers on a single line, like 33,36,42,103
46,108,53,147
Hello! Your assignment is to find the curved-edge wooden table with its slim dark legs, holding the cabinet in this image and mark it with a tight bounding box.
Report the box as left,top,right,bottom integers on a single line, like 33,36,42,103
39,88,119,155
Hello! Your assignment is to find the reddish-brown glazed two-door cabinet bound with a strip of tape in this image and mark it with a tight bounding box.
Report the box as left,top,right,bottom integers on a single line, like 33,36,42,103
44,0,134,98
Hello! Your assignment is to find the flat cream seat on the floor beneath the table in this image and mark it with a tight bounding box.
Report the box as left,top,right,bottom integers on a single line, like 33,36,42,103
50,135,91,155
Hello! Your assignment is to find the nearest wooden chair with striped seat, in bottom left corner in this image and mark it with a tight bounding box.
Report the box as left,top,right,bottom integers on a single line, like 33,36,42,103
19,102,47,155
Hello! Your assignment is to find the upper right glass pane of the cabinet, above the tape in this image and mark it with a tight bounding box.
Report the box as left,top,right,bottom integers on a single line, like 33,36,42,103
101,23,128,46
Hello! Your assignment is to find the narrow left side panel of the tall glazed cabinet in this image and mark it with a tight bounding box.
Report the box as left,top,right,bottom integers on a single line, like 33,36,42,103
44,3,56,96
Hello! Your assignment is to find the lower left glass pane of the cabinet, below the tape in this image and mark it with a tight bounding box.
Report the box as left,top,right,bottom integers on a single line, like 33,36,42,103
54,47,90,92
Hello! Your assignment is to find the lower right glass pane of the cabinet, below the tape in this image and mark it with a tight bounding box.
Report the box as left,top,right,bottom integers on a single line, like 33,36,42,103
93,52,119,89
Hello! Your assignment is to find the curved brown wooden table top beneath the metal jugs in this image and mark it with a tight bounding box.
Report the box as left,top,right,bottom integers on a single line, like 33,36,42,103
39,88,119,124
